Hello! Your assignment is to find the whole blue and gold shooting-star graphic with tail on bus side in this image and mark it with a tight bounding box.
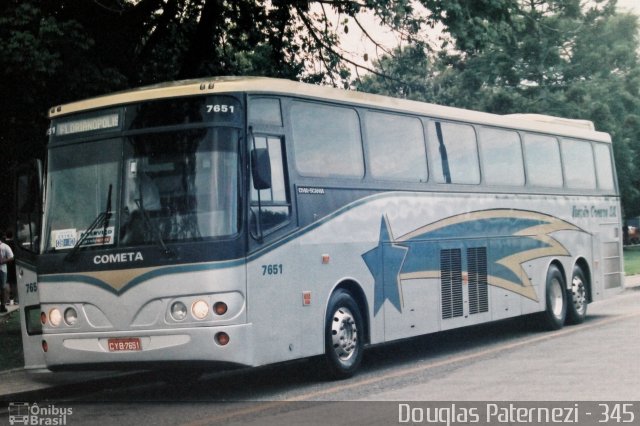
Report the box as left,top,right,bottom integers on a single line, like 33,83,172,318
362,209,585,314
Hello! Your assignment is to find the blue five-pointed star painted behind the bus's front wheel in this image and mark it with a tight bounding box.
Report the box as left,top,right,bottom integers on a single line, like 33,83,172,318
362,216,409,315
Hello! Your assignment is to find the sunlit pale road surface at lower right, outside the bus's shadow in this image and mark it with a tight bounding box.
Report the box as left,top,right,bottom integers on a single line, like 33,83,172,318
361,291,640,401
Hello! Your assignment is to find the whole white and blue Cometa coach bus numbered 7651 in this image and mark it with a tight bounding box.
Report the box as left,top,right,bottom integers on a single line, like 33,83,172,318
17,78,623,377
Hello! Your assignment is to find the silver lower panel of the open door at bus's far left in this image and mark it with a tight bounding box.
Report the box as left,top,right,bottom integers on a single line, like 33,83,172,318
16,260,45,369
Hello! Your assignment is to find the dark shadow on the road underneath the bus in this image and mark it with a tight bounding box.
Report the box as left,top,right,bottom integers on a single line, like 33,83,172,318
67,316,592,402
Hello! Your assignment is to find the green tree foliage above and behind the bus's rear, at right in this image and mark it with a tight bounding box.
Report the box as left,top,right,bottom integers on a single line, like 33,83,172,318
358,0,640,217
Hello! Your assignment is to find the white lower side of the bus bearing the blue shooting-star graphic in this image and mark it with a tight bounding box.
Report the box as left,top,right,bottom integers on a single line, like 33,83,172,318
247,188,619,364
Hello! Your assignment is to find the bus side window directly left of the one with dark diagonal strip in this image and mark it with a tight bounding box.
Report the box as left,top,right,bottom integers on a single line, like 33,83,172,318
365,112,427,182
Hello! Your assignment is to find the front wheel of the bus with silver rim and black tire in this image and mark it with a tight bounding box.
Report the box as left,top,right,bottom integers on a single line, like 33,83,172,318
324,289,364,379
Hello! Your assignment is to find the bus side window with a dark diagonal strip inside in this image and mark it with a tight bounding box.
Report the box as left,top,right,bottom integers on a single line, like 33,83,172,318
428,121,480,184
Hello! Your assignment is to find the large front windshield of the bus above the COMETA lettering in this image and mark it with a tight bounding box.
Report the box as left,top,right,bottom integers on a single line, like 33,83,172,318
45,127,239,251
